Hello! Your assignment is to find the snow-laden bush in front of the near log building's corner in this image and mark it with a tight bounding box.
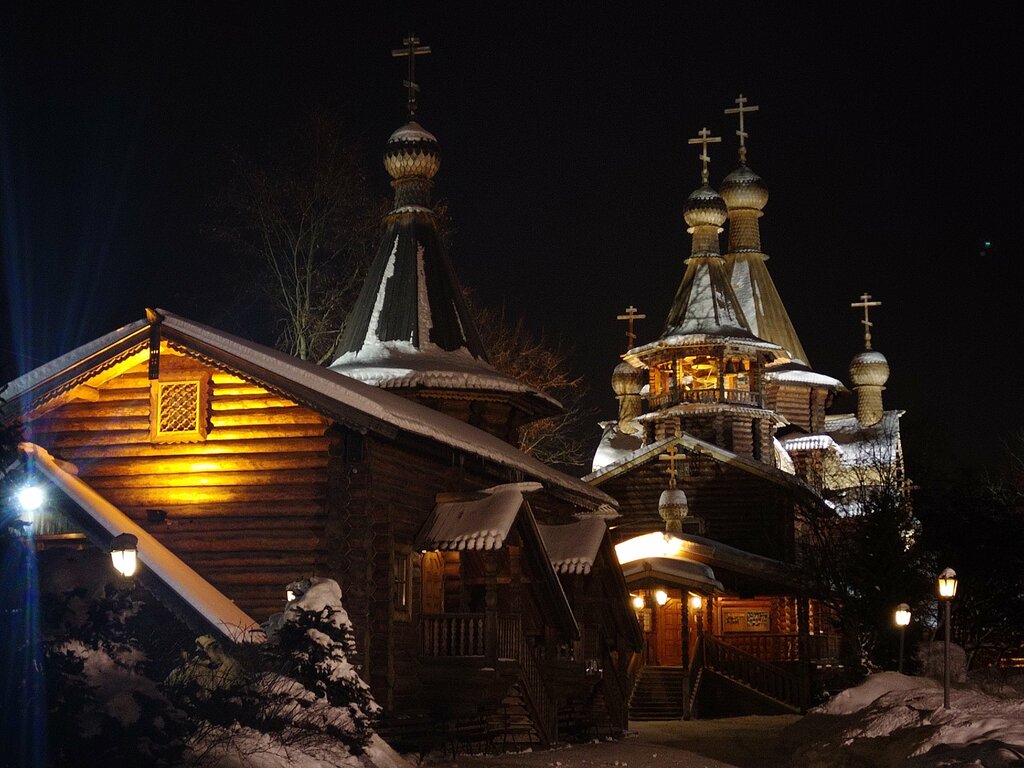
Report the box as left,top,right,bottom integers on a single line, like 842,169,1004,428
167,579,380,765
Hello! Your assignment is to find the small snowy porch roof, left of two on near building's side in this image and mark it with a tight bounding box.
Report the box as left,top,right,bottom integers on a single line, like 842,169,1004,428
417,485,523,551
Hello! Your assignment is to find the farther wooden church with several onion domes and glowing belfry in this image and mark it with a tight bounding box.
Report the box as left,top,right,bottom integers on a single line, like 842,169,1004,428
584,96,902,719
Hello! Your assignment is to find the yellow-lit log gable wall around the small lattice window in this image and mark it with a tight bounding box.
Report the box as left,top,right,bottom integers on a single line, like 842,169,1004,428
25,348,329,621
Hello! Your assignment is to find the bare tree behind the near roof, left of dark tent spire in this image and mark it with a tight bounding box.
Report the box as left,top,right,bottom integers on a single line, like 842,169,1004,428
217,112,385,364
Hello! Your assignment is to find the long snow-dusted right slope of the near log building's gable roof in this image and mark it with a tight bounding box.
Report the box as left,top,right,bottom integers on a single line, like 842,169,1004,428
157,309,618,510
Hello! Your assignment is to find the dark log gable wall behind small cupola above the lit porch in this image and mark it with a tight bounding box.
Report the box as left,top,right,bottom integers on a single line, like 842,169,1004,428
600,457,794,560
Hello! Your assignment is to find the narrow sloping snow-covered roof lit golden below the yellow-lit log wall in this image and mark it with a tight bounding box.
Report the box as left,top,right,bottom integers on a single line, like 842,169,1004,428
18,442,264,642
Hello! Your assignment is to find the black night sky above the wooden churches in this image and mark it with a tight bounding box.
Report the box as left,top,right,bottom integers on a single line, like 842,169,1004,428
0,2,1024,471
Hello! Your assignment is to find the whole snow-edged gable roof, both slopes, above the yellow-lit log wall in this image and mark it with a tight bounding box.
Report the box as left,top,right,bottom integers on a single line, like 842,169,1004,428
3,309,618,513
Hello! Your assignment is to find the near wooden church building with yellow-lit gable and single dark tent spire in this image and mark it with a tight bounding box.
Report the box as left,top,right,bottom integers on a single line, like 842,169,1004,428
2,46,643,746
